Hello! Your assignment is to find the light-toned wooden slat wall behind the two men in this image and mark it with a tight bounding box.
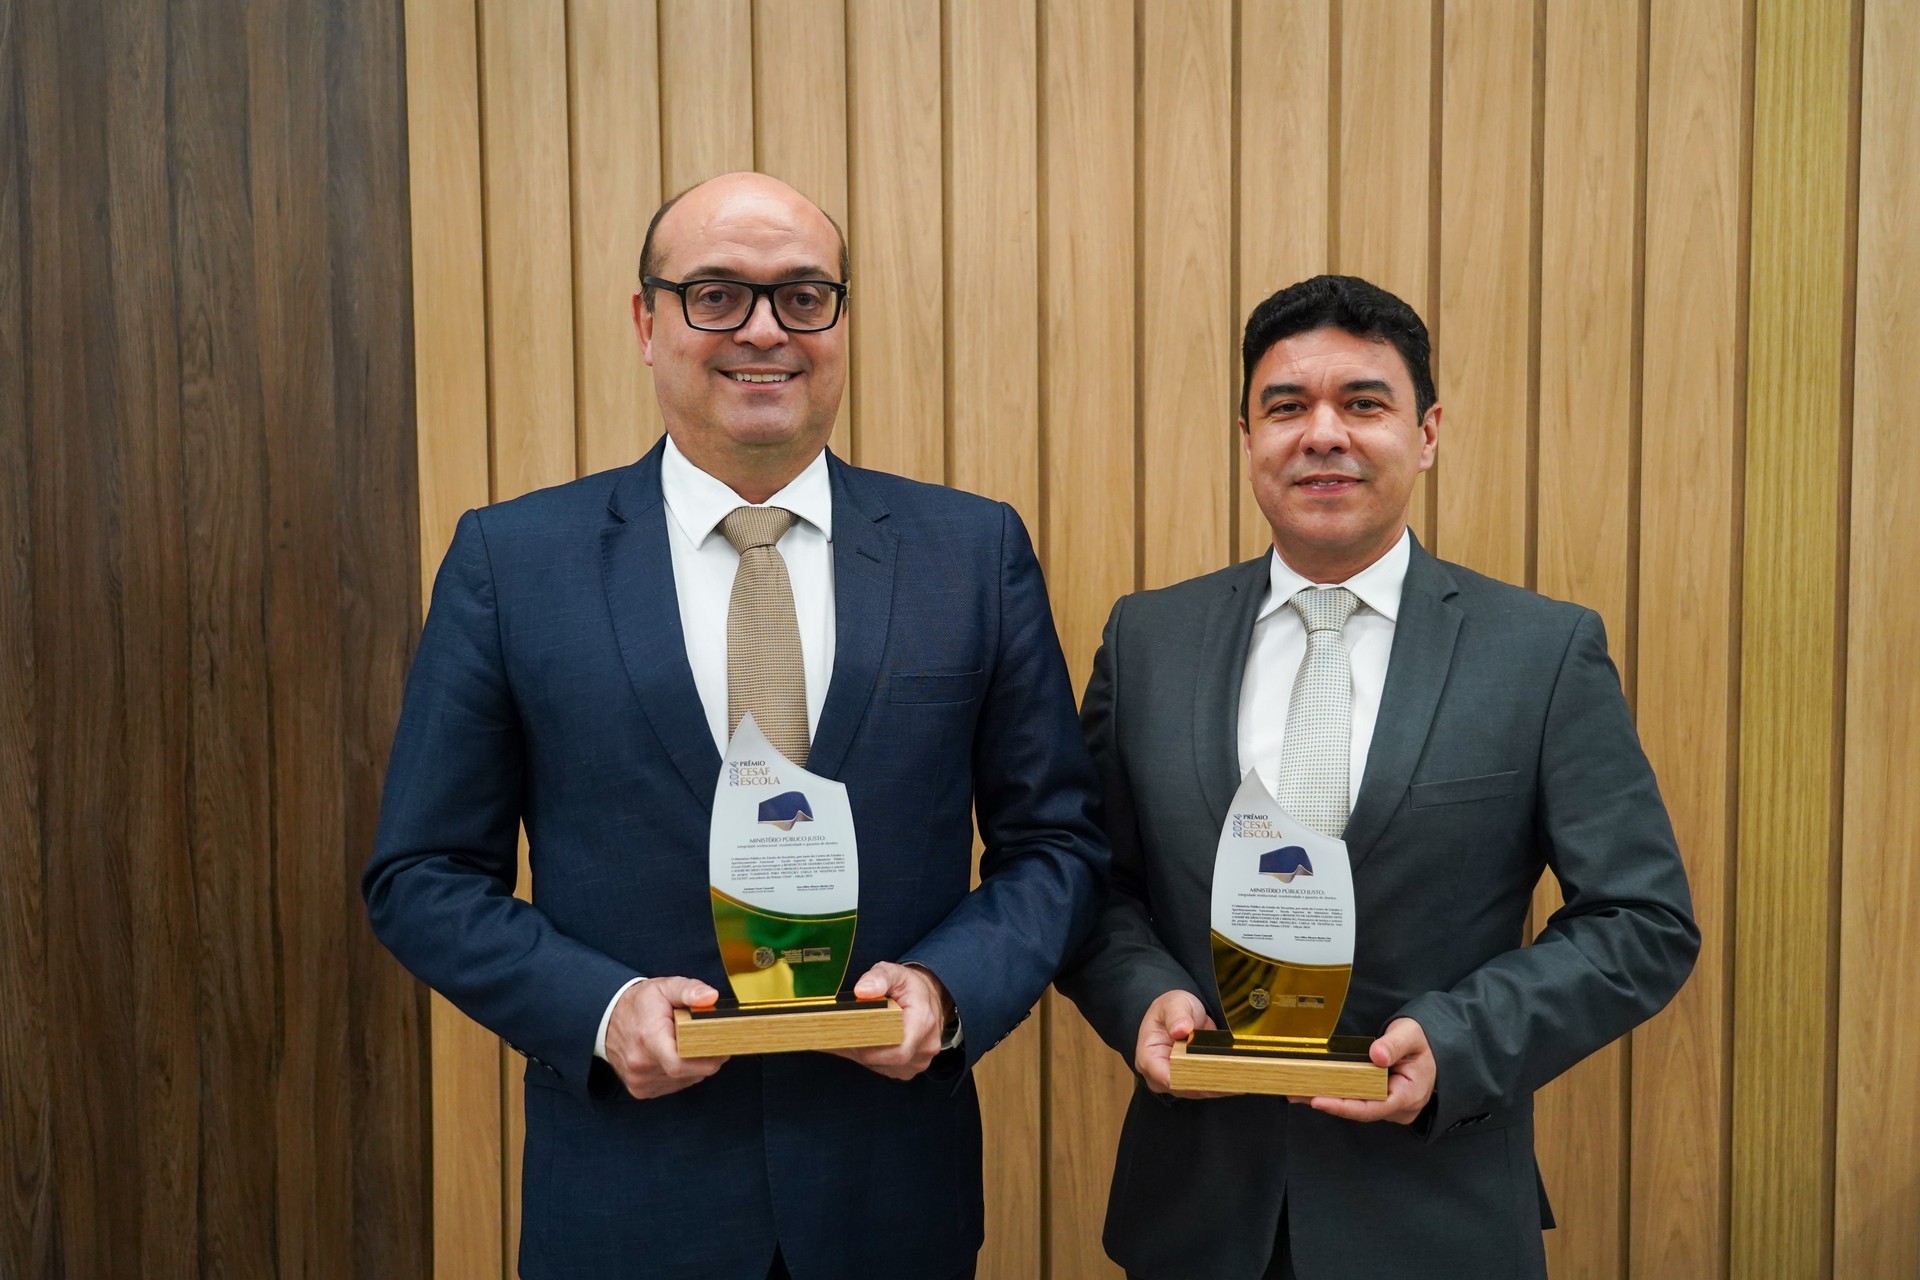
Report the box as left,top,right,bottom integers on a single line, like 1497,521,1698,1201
397,0,1920,1280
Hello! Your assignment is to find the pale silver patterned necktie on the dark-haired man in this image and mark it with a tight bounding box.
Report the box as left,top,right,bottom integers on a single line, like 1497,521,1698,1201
1279,587,1359,839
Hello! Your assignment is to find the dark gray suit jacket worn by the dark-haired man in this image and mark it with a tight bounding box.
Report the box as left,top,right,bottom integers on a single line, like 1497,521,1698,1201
1060,543,1699,1280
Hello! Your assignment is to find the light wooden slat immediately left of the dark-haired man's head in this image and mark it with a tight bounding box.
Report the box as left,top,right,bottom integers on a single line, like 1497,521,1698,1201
1137,4,1240,587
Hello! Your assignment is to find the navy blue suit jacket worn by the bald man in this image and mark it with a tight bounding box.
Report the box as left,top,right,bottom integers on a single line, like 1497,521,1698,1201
363,447,1106,1280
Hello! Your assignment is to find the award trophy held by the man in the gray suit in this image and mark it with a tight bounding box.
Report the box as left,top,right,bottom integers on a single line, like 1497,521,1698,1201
1171,770,1386,1100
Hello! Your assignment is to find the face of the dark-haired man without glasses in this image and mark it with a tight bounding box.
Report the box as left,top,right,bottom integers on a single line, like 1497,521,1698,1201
1240,328,1440,581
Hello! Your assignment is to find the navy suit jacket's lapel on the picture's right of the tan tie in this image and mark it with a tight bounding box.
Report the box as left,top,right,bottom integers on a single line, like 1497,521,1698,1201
806,453,899,777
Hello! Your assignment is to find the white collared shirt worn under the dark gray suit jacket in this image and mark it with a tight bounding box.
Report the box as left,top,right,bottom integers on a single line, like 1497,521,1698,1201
1238,532,1413,804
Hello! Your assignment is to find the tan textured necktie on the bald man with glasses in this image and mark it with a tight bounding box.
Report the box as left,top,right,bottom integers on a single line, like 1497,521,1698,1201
720,507,806,764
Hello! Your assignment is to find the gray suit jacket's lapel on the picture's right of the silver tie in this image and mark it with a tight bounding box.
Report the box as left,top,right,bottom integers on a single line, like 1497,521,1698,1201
1346,539,1461,865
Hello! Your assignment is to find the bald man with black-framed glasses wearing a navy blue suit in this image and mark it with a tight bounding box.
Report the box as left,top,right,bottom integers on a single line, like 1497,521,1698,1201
363,175,1106,1280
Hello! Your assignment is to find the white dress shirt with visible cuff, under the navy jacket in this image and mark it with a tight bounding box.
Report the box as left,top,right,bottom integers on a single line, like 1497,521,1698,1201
593,436,833,1057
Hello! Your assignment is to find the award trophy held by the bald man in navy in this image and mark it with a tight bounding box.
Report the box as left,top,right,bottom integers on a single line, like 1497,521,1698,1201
674,716,904,1057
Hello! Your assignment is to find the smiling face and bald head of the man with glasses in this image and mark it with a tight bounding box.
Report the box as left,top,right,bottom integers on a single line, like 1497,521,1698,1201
634,173,847,478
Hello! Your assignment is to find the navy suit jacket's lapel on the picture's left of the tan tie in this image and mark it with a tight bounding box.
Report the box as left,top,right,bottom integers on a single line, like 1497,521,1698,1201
601,445,720,804
